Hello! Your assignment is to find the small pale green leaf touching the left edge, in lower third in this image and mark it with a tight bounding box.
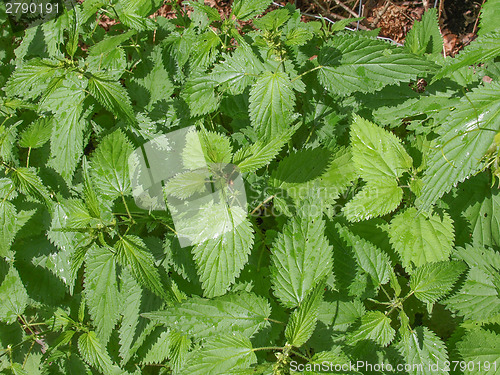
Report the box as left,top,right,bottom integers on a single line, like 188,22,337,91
0,265,28,324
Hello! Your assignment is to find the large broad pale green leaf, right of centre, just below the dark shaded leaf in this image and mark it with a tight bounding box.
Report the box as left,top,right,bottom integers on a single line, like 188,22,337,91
271,203,333,307
